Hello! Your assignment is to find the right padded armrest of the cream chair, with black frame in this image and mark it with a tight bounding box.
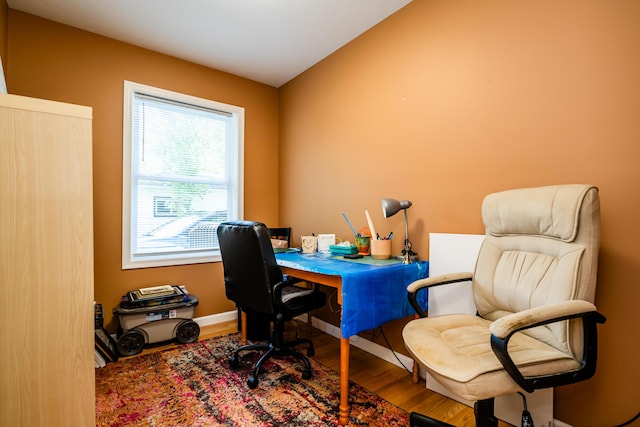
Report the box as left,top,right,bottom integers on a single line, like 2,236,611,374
489,300,606,393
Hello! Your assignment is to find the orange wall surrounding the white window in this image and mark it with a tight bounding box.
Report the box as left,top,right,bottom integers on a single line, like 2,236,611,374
7,10,278,330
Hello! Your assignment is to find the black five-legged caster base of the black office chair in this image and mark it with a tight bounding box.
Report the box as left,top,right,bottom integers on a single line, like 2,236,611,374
229,321,315,388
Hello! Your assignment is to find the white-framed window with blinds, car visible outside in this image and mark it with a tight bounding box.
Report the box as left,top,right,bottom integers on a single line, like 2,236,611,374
122,81,244,269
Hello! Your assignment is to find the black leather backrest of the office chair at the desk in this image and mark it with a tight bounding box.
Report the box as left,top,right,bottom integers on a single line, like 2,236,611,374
218,221,283,314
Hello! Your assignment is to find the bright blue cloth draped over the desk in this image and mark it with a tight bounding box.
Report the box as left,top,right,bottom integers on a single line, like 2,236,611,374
276,252,429,338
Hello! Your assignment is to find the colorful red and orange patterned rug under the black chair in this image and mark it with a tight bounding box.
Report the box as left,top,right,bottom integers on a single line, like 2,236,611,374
96,333,409,427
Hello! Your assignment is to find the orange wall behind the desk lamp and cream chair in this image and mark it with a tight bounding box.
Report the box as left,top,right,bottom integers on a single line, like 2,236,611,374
280,0,640,426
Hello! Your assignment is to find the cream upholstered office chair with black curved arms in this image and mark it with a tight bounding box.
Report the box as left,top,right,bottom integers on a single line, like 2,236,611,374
403,185,605,427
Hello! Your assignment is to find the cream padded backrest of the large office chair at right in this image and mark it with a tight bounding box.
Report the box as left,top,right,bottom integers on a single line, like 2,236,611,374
472,185,600,355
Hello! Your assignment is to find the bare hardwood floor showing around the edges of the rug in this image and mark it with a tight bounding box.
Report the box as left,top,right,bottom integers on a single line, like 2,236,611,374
134,321,510,427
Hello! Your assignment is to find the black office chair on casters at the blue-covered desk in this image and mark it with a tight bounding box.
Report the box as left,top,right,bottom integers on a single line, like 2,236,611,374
218,221,326,388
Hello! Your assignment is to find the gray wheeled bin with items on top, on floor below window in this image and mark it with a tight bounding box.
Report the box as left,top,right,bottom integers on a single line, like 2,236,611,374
113,286,200,356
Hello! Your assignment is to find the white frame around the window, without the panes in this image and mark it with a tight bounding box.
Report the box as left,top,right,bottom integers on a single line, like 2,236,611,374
122,80,244,270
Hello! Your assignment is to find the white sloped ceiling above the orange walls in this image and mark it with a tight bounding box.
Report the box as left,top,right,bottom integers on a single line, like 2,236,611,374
7,0,411,87
